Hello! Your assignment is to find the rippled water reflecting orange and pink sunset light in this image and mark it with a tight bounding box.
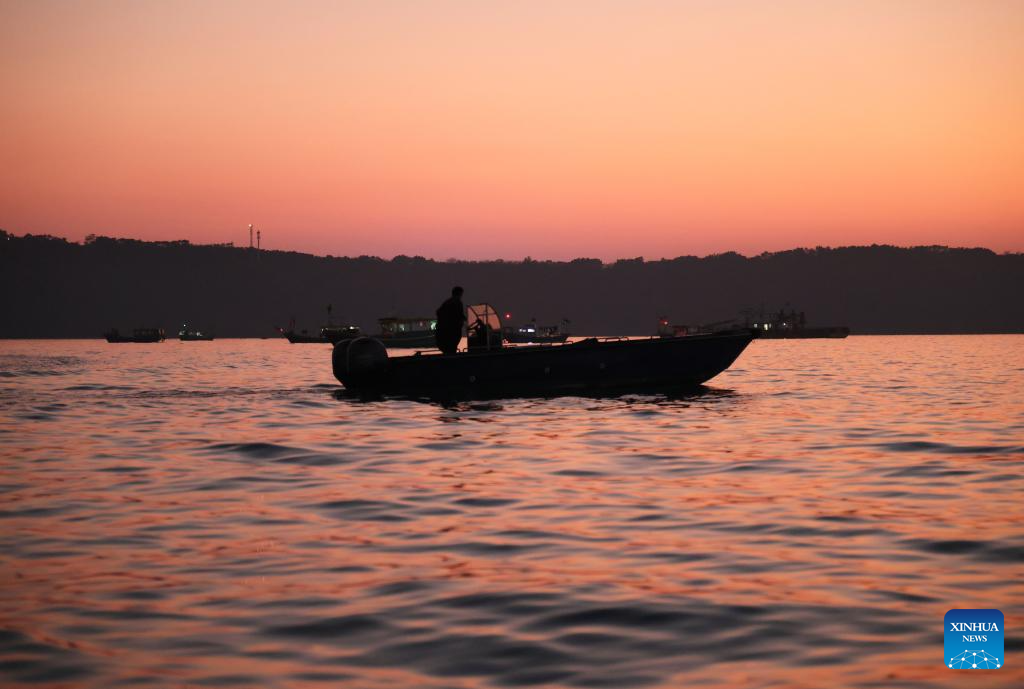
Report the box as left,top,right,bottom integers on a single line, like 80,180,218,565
0,336,1024,688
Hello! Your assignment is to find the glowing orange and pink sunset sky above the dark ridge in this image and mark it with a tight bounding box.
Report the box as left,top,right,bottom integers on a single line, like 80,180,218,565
0,0,1024,259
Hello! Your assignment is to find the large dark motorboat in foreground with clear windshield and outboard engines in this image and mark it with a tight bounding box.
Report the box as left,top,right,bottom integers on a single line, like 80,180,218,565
332,304,753,397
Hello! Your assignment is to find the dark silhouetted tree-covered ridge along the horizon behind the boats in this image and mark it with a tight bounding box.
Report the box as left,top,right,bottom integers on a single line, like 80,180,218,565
0,230,1024,338
